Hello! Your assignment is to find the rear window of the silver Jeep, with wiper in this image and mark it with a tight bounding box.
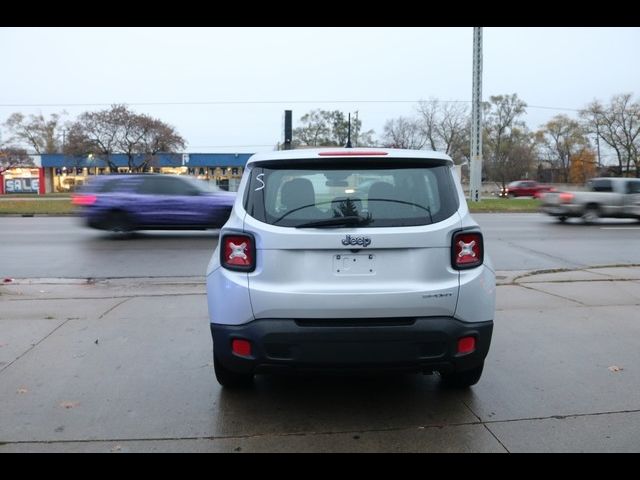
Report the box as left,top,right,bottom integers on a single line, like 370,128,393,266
245,159,458,228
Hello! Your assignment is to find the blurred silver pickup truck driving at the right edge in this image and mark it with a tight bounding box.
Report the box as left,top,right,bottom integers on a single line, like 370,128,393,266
541,178,640,223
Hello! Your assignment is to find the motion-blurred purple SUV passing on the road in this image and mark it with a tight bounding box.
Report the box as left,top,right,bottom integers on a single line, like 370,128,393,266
72,174,236,232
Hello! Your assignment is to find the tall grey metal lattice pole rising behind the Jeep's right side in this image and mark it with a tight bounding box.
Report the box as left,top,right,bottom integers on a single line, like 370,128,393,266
469,27,482,202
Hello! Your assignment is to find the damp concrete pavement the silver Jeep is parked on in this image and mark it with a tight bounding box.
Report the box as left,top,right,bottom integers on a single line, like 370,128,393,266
0,267,640,452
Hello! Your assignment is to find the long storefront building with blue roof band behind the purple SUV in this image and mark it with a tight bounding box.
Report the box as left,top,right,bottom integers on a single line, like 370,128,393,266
0,153,252,195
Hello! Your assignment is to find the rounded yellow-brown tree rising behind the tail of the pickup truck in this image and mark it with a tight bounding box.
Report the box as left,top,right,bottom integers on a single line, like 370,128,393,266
541,114,589,183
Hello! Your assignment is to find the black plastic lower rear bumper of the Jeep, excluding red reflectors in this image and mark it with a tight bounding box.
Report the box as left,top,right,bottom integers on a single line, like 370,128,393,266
211,317,493,374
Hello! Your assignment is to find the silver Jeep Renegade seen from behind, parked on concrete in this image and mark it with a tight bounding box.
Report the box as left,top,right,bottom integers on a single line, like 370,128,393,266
207,148,495,387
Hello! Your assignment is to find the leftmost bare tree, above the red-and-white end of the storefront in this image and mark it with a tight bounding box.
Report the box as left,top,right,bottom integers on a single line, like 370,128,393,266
4,112,66,154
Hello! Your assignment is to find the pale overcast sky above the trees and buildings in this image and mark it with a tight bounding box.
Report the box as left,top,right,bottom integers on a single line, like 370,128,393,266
0,27,640,152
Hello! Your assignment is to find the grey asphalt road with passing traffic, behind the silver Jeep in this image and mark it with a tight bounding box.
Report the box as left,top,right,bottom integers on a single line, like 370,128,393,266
0,213,640,278
